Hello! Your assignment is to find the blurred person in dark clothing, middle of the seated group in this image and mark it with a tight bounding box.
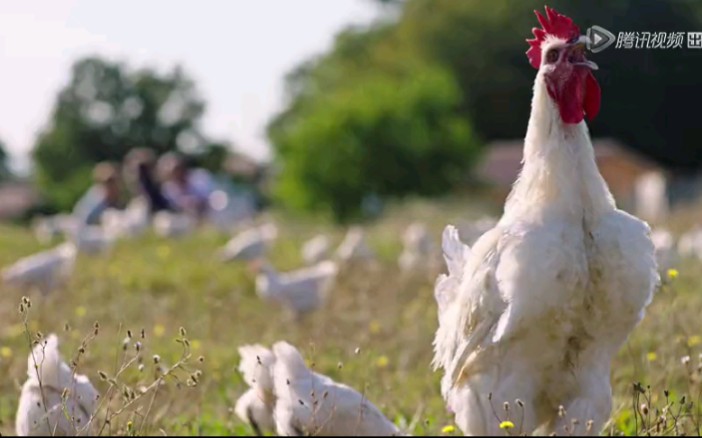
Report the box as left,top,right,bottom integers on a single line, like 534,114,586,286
124,148,173,214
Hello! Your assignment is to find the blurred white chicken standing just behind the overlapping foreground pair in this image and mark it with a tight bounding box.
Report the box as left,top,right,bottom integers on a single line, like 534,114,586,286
256,260,338,319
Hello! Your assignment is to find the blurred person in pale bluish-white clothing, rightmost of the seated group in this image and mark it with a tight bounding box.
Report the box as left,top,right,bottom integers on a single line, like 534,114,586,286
158,152,216,219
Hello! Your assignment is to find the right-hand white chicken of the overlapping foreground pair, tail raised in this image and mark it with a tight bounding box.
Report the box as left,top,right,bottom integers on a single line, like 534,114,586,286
273,341,401,436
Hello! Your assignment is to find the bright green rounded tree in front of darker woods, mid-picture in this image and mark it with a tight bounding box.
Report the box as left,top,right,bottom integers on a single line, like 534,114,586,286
268,26,484,221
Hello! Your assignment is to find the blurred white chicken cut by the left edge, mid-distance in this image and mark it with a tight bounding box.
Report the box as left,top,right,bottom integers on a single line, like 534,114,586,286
2,242,77,295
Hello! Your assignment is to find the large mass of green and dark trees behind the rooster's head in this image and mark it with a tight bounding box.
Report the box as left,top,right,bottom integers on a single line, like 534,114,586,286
268,0,702,218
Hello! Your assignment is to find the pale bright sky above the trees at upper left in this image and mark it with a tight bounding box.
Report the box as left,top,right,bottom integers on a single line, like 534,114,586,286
0,0,378,170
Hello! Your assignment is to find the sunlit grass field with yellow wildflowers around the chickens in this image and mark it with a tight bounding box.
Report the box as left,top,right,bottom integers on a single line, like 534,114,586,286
0,198,702,435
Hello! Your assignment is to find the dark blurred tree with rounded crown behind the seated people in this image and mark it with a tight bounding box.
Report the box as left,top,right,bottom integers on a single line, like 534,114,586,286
33,57,204,209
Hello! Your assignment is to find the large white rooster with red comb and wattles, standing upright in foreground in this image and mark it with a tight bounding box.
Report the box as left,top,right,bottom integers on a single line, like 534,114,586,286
433,8,660,435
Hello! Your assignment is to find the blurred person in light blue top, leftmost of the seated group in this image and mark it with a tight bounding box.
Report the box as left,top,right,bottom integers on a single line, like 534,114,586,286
73,162,122,225
